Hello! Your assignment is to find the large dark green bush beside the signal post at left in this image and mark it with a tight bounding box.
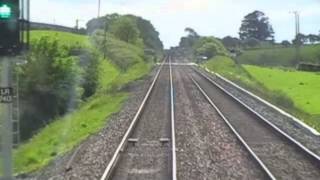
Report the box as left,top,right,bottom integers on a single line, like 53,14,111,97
19,37,81,139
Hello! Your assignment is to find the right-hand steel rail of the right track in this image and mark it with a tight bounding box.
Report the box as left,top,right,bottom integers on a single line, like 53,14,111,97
193,68,320,162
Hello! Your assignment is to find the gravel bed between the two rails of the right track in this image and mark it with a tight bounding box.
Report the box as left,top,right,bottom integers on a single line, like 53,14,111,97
192,68,320,179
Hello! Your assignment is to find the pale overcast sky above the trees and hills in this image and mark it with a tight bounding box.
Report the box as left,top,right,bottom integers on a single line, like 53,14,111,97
30,0,320,47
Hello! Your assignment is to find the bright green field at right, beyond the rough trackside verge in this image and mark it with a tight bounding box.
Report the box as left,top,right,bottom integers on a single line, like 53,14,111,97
244,65,320,114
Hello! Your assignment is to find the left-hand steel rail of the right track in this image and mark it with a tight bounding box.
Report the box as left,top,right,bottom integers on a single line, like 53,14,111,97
190,77,276,180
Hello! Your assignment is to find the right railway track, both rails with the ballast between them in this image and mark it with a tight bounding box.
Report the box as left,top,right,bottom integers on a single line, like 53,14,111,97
187,68,320,179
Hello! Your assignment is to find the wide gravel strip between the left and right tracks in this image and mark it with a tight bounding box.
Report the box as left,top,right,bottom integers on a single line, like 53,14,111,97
173,66,266,180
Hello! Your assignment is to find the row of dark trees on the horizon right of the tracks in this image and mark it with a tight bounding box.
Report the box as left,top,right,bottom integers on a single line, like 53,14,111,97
179,10,320,51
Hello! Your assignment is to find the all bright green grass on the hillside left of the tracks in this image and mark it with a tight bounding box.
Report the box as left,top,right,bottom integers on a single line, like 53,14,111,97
14,31,151,174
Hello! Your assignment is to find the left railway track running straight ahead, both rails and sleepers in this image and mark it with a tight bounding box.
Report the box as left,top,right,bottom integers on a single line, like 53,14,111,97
101,57,176,180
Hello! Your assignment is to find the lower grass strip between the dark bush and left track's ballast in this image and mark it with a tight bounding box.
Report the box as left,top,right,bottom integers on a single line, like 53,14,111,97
14,93,127,173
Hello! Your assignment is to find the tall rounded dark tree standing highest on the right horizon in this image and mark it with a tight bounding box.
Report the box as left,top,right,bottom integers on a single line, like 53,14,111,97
239,11,274,41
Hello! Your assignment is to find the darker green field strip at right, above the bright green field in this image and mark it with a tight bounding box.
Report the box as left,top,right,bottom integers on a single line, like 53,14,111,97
238,44,320,66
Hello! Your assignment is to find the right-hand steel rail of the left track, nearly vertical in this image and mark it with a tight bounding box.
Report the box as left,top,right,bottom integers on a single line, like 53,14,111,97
169,56,177,180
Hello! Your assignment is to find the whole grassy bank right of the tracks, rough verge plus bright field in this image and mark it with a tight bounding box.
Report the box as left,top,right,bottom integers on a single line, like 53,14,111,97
204,56,320,131
